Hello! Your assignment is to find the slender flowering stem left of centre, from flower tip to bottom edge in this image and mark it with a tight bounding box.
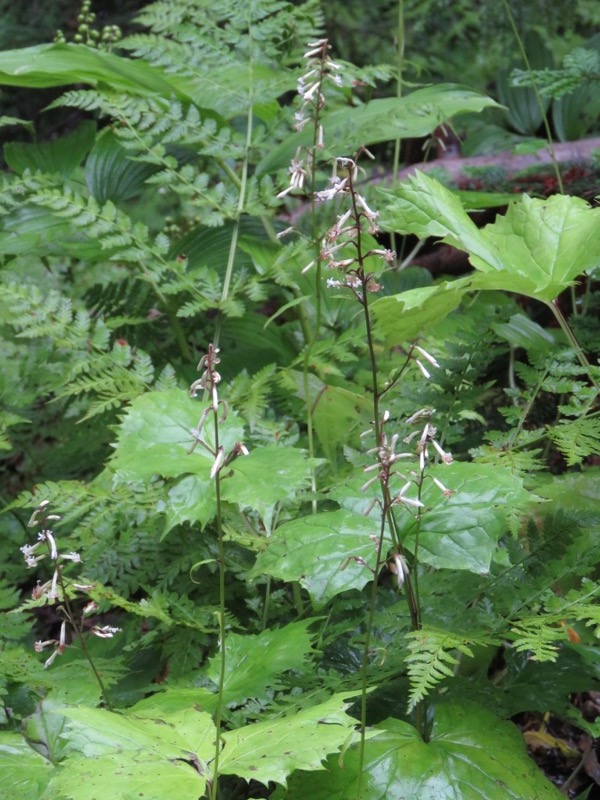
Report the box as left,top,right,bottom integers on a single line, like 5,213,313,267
188,344,248,800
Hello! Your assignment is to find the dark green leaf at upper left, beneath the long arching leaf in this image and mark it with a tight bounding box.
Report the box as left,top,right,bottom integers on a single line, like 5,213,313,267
4,120,96,178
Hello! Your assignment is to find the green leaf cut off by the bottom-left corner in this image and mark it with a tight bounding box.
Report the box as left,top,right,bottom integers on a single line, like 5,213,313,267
0,731,54,800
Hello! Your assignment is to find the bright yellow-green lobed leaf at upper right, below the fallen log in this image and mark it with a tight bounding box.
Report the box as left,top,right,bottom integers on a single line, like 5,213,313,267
385,173,600,302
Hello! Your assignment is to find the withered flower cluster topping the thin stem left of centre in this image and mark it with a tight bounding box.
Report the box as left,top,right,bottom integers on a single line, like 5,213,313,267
188,344,248,479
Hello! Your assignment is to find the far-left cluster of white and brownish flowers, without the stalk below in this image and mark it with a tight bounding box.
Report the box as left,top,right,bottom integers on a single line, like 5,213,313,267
21,500,120,667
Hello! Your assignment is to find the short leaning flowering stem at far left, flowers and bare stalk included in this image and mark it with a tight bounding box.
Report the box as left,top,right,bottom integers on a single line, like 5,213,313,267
21,500,120,709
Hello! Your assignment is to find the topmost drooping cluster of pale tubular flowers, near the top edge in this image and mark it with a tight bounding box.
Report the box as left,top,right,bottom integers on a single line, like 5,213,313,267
277,39,342,199
